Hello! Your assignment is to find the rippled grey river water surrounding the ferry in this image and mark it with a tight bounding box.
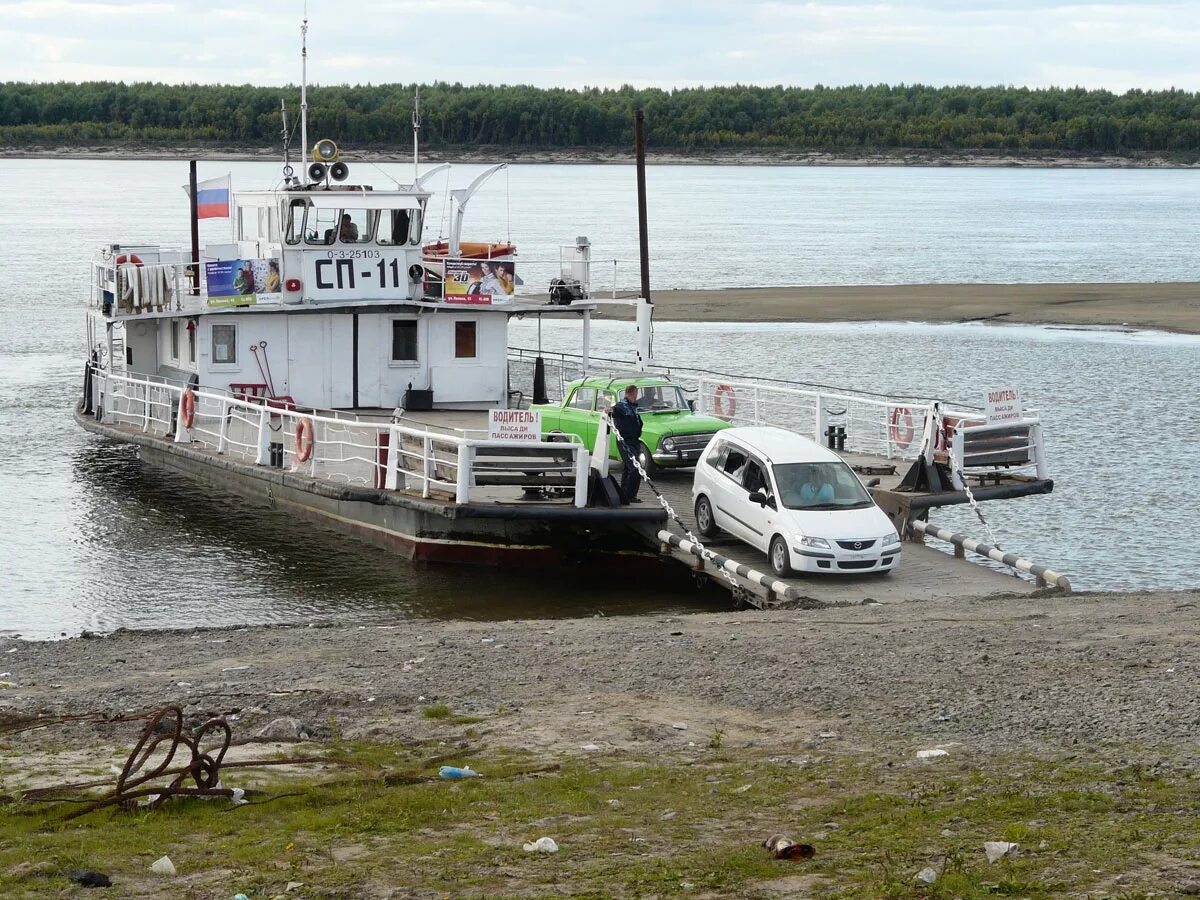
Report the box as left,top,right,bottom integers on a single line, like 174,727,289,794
0,161,1200,637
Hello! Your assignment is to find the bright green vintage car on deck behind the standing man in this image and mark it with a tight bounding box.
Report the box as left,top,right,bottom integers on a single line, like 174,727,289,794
530,376,730,473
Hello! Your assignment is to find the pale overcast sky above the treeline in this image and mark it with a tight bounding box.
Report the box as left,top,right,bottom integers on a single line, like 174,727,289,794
0,0,1200,91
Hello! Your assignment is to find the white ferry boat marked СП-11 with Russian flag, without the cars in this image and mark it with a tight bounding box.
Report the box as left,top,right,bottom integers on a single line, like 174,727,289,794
76,33,1064,605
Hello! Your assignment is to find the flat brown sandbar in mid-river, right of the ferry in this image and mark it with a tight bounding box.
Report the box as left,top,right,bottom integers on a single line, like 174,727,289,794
605,282,1200,334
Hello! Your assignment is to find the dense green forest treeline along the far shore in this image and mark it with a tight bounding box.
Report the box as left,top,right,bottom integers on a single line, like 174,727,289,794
0,82,1200,155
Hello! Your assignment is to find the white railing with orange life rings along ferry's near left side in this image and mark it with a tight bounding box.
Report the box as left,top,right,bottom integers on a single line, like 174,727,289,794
94,370,589,506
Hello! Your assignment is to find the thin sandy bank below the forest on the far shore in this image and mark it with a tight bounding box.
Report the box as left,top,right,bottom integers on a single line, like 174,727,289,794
9,144,1200,169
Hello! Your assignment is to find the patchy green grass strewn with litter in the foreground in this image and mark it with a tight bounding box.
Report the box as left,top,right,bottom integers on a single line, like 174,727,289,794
0,744,1200,898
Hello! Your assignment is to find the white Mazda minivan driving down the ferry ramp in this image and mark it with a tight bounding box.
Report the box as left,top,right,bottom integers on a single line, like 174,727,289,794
691,426,900,576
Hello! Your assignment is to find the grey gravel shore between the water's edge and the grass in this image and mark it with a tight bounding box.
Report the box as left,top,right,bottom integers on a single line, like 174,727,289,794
0,593,1200,766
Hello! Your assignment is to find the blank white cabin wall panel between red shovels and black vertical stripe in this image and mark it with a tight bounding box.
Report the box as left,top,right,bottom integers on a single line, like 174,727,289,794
288,313,354,409
